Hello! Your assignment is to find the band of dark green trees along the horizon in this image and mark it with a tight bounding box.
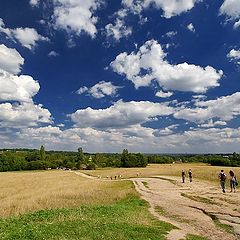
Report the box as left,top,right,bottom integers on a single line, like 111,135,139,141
0,146,240,172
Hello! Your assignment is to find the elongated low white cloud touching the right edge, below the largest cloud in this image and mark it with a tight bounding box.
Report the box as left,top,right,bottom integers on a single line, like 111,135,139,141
174,92,240,122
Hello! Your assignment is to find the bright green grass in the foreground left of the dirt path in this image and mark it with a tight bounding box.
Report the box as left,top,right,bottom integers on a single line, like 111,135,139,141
0,195,173,240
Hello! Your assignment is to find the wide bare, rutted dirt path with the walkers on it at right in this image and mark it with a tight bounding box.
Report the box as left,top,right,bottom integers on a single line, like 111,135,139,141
74,173,240,240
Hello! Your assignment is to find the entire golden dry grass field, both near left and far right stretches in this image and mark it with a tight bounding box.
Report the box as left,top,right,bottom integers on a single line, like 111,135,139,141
0,164,240,217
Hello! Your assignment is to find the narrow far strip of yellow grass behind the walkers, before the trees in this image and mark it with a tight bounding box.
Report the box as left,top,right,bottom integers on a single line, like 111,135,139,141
87,163,240,182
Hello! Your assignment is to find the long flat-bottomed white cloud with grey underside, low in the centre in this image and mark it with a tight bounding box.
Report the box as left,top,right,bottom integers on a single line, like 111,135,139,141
70,101,174,128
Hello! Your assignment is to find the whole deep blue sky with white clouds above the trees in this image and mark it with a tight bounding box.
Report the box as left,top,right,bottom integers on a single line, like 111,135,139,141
0,0,240,153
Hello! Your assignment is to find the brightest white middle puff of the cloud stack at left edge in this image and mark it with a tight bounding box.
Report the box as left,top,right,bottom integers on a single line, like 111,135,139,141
0,69,40,102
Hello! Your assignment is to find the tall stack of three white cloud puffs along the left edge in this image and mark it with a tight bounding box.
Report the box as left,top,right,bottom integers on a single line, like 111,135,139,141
0,45,52,129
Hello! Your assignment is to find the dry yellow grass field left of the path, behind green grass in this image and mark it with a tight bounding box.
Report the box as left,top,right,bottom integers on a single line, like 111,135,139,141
0,170,135,217
